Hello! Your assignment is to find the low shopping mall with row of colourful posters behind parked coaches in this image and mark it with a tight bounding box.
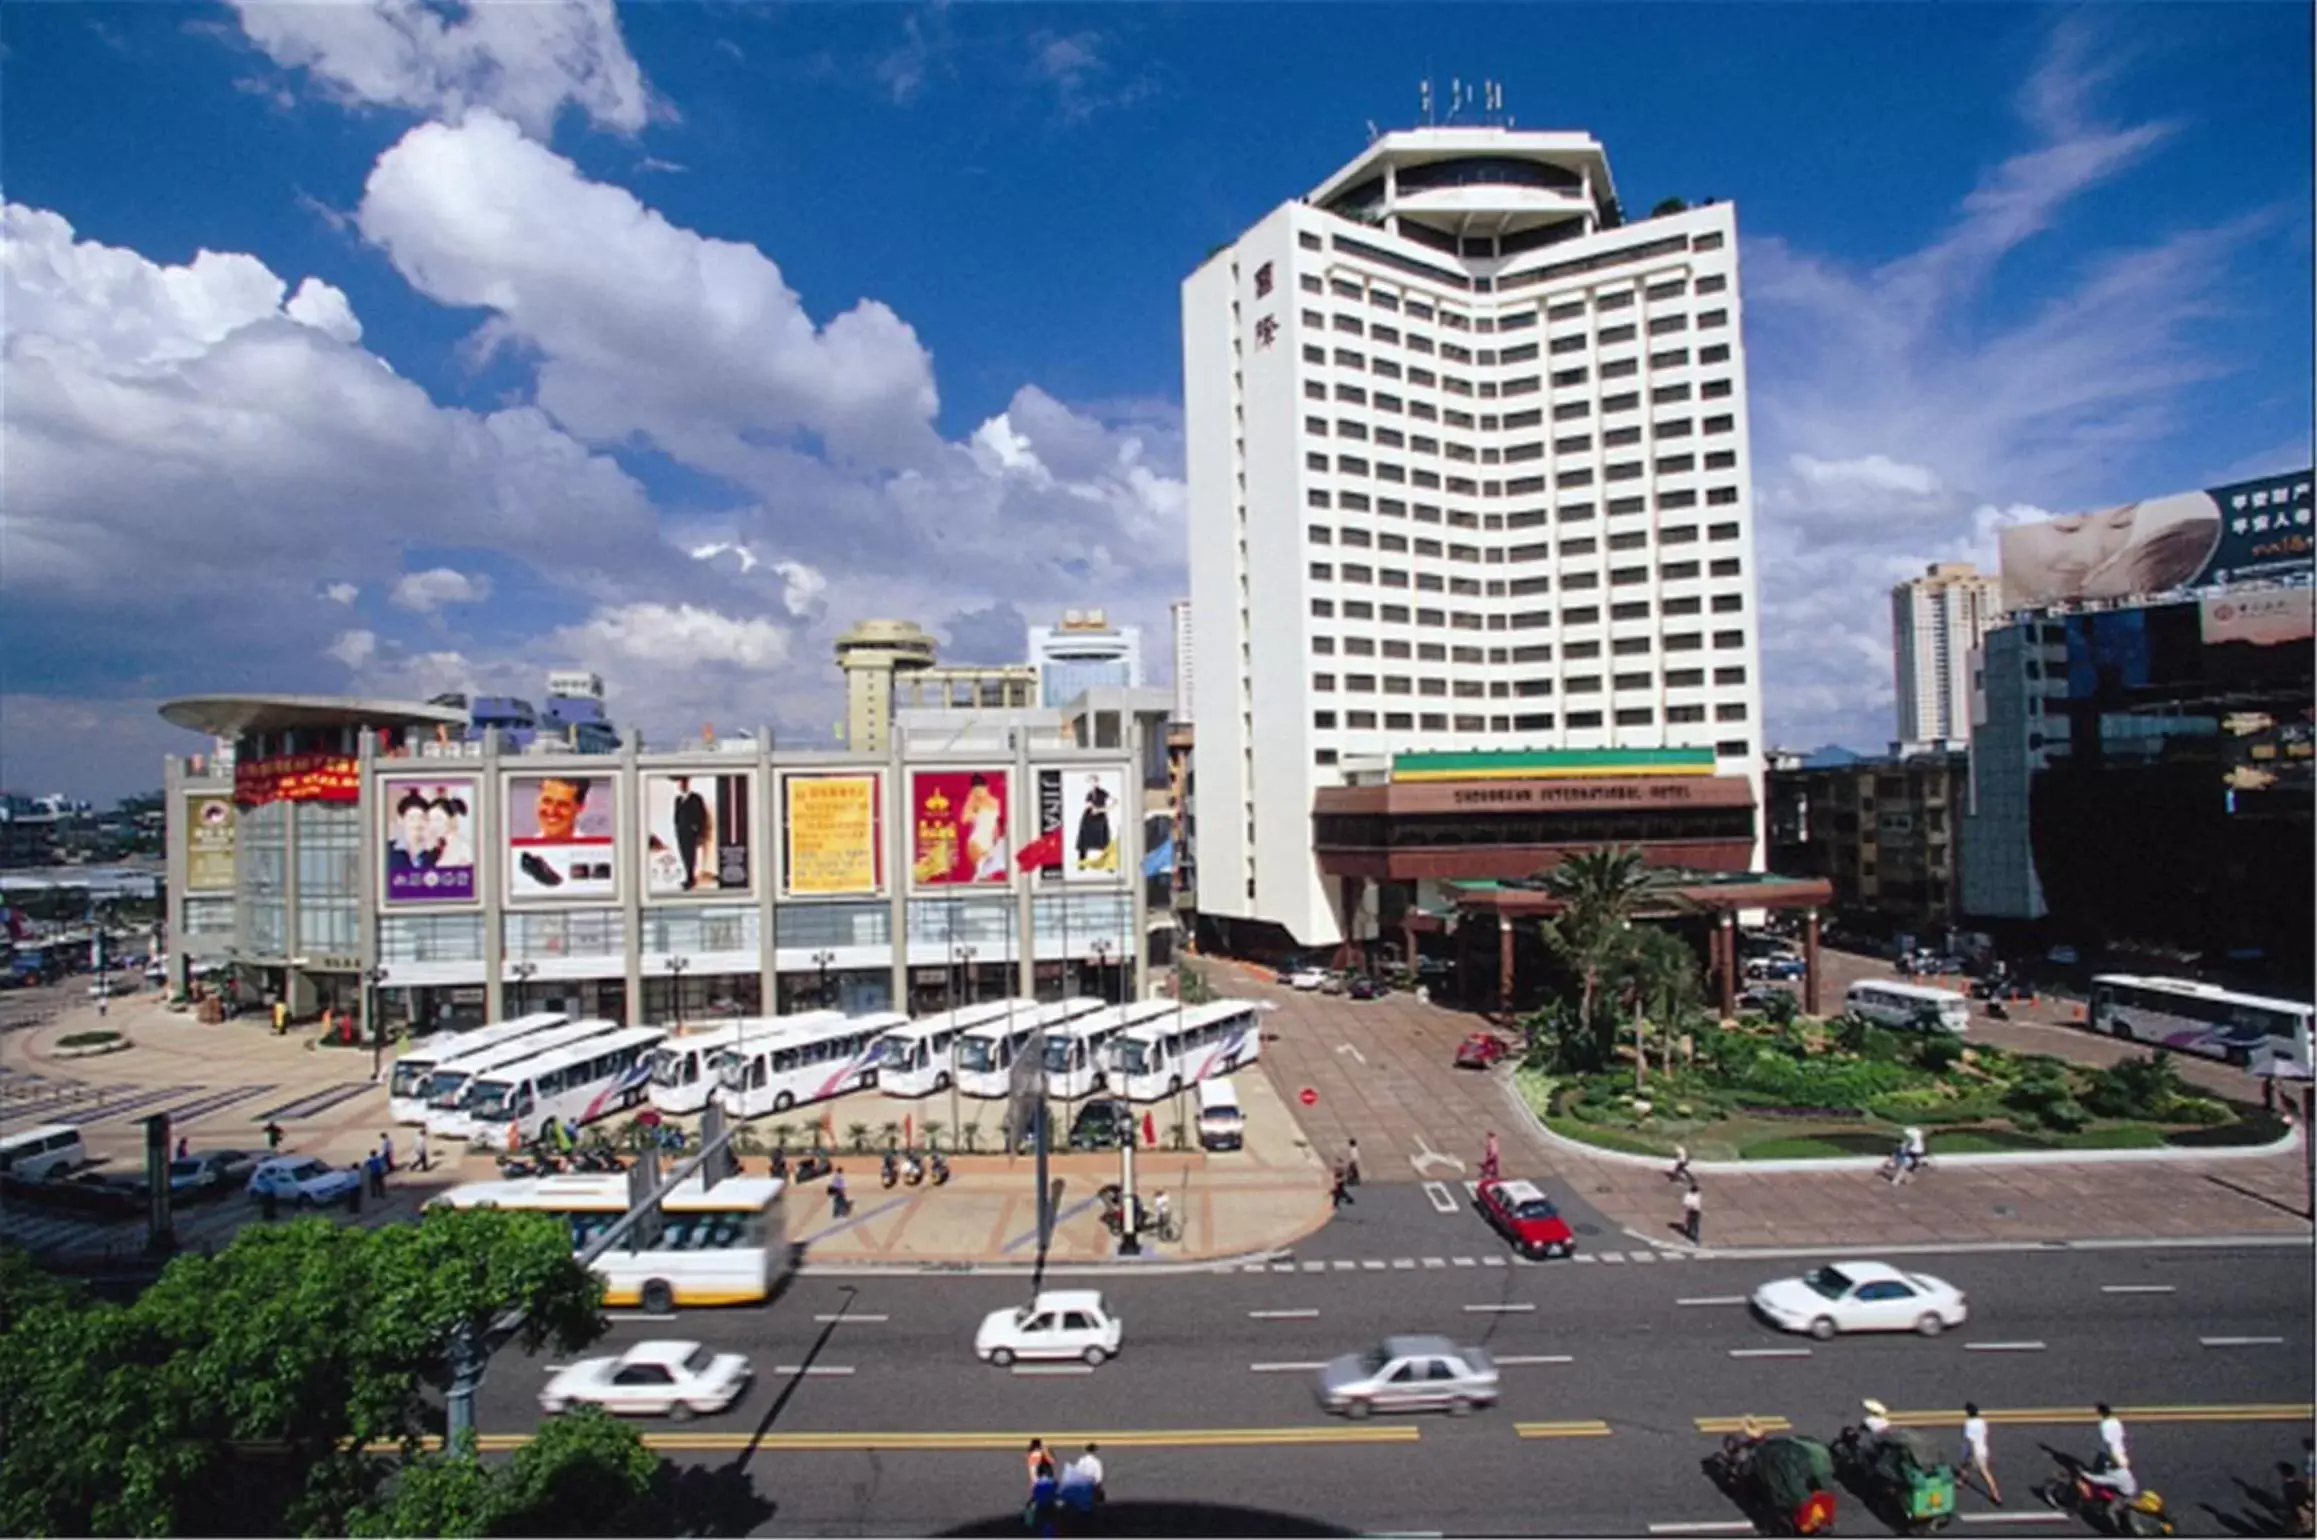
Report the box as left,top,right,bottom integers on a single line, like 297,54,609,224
162,695,1163,1026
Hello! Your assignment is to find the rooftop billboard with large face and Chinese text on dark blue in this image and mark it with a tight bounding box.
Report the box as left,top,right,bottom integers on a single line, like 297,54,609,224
2000,470,2317,609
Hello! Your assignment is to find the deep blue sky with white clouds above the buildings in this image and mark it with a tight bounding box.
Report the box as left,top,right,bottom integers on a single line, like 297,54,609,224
0,0,2312,794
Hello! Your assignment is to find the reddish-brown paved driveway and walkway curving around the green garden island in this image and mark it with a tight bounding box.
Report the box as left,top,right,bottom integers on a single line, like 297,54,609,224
1203,959,2310,1248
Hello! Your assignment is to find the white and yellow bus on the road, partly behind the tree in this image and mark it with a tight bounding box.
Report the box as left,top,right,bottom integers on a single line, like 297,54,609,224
429,1174,795,1315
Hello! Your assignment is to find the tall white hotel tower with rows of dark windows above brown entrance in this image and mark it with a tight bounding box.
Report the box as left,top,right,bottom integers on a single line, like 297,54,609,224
1182,127,1761,945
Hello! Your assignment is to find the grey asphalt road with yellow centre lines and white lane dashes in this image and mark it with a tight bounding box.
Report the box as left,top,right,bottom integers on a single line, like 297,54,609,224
480,1248,2317,1533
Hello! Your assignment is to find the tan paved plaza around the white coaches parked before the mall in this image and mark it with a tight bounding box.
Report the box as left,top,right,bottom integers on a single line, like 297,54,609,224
0,996,1330,1267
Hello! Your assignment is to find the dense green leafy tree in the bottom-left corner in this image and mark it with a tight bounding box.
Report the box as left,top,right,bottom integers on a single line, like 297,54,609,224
0,1209,602,1535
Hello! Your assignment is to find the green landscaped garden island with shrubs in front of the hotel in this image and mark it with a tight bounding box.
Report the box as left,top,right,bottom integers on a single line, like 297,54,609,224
1515,1017,2285,1160
